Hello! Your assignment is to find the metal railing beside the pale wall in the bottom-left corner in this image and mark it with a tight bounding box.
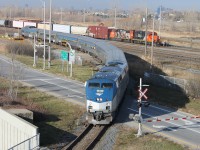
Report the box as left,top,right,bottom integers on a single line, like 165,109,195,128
8,134,40,150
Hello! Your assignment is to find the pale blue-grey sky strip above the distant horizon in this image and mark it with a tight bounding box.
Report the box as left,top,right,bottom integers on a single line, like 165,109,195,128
0,0,200,10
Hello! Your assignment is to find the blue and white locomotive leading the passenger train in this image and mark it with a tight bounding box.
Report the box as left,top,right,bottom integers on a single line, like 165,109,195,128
86,61,129,125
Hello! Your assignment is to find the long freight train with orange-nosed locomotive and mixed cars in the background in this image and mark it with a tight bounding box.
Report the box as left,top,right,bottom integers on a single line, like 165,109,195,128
0,19,162,45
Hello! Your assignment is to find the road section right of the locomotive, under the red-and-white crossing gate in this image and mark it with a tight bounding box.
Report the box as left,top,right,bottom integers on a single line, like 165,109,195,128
117,96,200,149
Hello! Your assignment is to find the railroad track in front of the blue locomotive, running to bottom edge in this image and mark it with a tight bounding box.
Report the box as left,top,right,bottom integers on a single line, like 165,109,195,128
62,125,109,150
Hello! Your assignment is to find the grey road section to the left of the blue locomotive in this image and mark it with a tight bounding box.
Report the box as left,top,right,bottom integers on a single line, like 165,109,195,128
0,55,85,105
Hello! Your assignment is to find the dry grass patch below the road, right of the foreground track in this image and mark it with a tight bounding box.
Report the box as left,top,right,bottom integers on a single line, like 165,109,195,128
114,127,187,150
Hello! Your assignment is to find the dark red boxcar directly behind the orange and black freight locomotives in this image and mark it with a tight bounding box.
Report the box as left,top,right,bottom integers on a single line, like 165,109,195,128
87,26,108,39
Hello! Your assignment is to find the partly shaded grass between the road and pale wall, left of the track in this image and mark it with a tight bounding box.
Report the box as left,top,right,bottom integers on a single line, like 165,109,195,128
0,78,84,146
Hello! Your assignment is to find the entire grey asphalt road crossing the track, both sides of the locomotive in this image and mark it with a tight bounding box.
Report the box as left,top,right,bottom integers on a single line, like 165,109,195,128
0,55,200,149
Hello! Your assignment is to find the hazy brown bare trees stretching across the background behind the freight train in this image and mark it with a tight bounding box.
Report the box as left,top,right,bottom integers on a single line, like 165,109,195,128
0,5,200,32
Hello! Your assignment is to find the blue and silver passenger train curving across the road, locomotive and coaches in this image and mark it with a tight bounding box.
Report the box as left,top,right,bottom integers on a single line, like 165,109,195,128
21,22,129,125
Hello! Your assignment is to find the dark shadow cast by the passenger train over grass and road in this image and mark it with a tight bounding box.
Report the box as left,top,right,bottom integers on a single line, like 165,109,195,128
116,53,189,123
